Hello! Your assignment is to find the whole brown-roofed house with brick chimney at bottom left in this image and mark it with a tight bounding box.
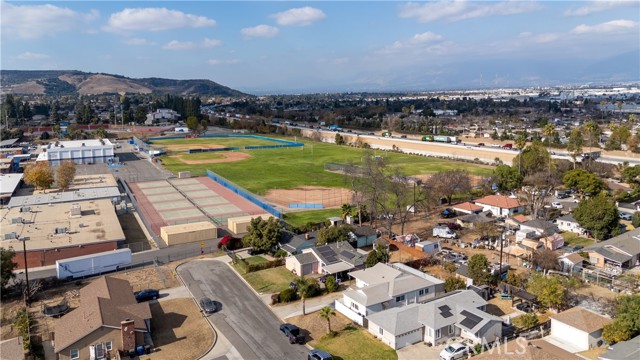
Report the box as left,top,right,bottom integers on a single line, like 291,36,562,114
54,276,153,360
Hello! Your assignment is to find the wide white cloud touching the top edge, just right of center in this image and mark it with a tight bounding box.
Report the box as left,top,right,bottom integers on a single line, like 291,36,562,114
399,0,541,23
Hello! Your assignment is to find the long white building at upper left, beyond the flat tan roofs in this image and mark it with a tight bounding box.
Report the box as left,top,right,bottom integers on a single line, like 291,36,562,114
36,139,114,165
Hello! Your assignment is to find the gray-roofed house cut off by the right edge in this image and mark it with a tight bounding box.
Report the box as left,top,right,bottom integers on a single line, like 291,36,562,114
583,228,640,272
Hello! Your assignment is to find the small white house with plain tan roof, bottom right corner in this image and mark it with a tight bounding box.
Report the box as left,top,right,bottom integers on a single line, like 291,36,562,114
544,306,612,353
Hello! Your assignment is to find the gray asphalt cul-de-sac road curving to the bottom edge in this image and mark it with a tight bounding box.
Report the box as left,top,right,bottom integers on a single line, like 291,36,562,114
177,260,308,360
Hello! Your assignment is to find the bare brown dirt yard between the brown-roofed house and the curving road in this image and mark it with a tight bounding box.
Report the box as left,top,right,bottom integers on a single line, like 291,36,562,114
140,299,214,360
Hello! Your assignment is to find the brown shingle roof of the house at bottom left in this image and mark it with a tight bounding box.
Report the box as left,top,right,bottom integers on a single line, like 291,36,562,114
55,276,151,353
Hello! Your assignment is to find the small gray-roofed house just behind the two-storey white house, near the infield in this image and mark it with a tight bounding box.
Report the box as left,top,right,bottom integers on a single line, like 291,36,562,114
285,241,366,276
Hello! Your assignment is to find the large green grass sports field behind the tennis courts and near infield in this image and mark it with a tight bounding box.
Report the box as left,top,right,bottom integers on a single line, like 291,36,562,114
160,138,493,195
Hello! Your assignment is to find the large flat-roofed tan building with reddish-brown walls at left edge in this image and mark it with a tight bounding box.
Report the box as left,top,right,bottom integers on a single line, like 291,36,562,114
0,200,125,269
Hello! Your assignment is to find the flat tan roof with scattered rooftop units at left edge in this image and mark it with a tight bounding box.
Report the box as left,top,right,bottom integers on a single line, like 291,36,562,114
0,200,125,251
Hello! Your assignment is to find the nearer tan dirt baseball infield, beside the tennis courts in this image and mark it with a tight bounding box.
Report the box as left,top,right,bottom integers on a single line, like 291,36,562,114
264,186,351,208
